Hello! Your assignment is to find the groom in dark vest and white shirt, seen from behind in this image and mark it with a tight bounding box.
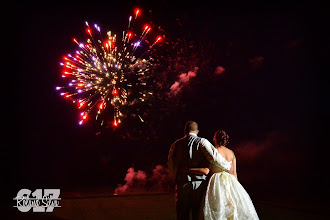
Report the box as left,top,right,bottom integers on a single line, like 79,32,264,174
168,121,228,220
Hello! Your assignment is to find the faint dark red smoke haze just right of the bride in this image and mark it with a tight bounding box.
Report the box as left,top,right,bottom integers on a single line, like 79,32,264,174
233,132,303,184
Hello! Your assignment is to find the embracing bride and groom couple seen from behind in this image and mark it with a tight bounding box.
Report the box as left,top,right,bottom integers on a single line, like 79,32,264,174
168,121,259,220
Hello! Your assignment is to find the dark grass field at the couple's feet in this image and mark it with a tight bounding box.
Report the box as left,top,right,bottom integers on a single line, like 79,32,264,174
5,190,329,220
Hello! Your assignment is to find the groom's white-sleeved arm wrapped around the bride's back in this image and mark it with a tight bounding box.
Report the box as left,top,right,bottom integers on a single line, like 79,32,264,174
199,138,231,170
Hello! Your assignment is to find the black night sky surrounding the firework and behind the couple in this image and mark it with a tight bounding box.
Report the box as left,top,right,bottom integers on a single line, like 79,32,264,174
5,1,325,204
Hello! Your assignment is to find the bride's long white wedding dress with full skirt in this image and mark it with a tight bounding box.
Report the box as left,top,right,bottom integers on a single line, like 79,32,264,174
203,162,259,220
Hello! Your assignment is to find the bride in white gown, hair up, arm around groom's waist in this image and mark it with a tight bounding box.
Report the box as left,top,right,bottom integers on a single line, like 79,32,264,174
188,130,259,220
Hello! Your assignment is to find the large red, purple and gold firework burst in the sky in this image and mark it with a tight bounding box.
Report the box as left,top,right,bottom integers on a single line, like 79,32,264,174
56,9,164,127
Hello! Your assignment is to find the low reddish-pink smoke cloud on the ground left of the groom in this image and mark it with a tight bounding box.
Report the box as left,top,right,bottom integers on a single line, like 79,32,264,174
114,165,174,195
